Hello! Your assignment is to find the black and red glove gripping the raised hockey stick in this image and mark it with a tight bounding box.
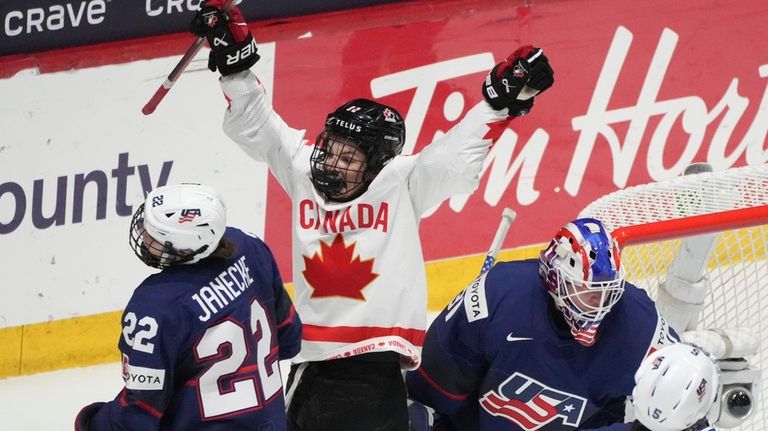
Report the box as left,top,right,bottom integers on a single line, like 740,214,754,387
189,0,259,76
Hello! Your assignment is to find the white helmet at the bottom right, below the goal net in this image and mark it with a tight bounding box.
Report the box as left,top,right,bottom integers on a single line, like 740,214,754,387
632,343,720,431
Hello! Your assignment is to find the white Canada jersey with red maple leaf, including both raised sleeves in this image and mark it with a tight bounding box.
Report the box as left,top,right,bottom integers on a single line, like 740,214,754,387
221,72,506,368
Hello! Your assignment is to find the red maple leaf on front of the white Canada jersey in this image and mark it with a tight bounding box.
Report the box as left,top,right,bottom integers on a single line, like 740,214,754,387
302,234,379,301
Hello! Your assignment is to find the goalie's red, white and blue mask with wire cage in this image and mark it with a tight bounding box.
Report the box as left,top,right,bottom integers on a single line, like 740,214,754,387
539,218,624,346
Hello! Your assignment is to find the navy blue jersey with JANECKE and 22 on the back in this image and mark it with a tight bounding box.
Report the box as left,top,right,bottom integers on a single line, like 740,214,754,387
78,228,301,431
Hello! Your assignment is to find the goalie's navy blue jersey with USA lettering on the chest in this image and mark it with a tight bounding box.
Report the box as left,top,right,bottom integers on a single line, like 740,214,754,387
407,260,677,431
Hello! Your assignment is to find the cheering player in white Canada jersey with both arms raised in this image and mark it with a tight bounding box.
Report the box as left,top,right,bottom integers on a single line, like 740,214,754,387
192,0,554,431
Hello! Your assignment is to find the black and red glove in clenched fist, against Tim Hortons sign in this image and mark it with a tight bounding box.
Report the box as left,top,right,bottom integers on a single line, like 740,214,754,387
483,45,555,117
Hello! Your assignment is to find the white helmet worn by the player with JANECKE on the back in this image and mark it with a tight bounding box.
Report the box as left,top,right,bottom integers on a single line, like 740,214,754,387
129,184,227,268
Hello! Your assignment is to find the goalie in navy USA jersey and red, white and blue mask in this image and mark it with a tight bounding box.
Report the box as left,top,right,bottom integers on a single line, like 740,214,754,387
407,219,677,431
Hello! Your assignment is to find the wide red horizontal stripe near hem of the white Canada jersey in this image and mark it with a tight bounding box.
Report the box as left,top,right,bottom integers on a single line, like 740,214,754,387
301,324,426,347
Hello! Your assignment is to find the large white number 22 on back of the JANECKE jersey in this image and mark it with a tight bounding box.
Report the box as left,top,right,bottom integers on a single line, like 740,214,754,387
195,301,283,418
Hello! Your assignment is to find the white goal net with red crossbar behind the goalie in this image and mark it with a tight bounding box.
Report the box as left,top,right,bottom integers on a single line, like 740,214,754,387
579,165,768,431
